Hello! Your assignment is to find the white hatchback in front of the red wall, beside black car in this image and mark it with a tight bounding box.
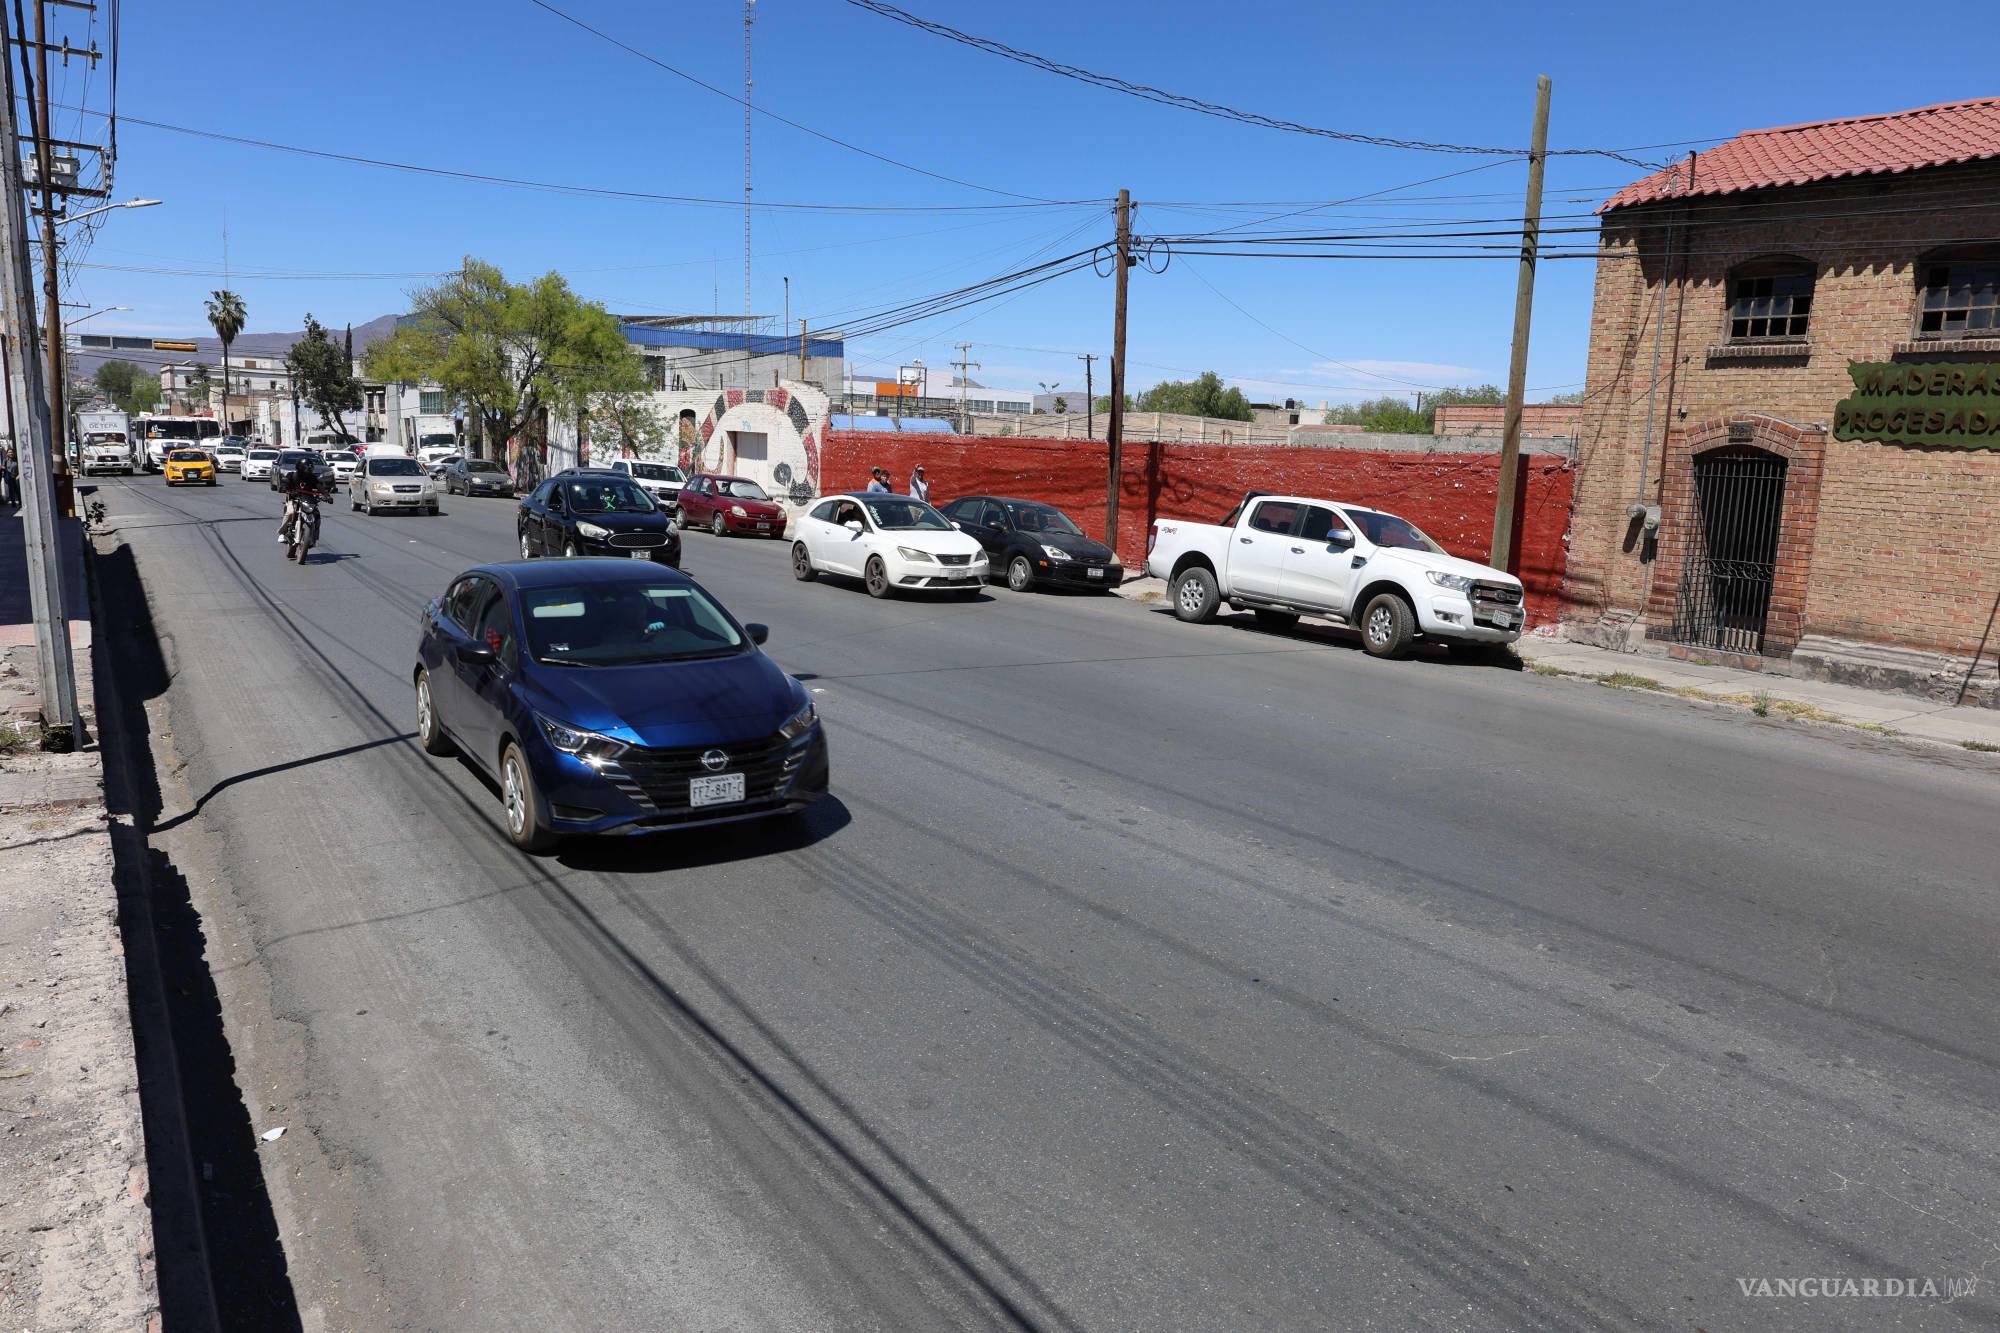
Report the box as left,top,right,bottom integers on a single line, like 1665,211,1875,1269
792,494,992,596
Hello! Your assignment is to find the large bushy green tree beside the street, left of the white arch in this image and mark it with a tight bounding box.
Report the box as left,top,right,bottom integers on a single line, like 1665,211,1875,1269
366,256,644,460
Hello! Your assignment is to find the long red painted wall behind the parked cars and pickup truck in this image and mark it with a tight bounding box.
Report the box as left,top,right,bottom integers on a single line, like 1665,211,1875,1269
820,430,1574,624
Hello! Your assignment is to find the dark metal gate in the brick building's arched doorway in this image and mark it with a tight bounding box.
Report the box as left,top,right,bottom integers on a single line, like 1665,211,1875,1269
1674,448,1786,652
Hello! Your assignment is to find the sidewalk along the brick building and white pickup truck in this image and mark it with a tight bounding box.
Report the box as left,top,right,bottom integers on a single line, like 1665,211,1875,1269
1118,578,2000,753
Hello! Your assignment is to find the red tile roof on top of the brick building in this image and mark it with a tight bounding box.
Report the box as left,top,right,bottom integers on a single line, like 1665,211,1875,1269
1598,98,2000,212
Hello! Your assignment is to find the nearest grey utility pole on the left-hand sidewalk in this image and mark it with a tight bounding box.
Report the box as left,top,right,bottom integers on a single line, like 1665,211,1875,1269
0,4,76,751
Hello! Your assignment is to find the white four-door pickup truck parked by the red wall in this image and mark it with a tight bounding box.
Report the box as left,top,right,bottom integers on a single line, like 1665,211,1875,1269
1146,490,1526,656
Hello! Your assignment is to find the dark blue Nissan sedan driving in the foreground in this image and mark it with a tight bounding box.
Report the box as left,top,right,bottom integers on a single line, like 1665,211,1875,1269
414,558,828,851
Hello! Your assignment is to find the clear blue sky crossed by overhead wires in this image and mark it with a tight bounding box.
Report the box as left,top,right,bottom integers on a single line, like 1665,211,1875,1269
54,0,2000,402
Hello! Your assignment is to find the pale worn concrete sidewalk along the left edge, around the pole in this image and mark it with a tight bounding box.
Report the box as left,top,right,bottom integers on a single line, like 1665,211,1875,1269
0,496,160,1331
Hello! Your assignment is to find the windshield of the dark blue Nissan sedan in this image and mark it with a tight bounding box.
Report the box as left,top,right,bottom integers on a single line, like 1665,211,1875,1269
522,580,746,667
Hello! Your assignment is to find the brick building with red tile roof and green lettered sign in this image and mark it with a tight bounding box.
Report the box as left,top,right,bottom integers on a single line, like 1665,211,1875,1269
1564,98,2000,707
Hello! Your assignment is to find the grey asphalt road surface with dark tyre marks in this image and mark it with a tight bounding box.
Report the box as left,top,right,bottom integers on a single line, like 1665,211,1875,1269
86,478,2000,1329
